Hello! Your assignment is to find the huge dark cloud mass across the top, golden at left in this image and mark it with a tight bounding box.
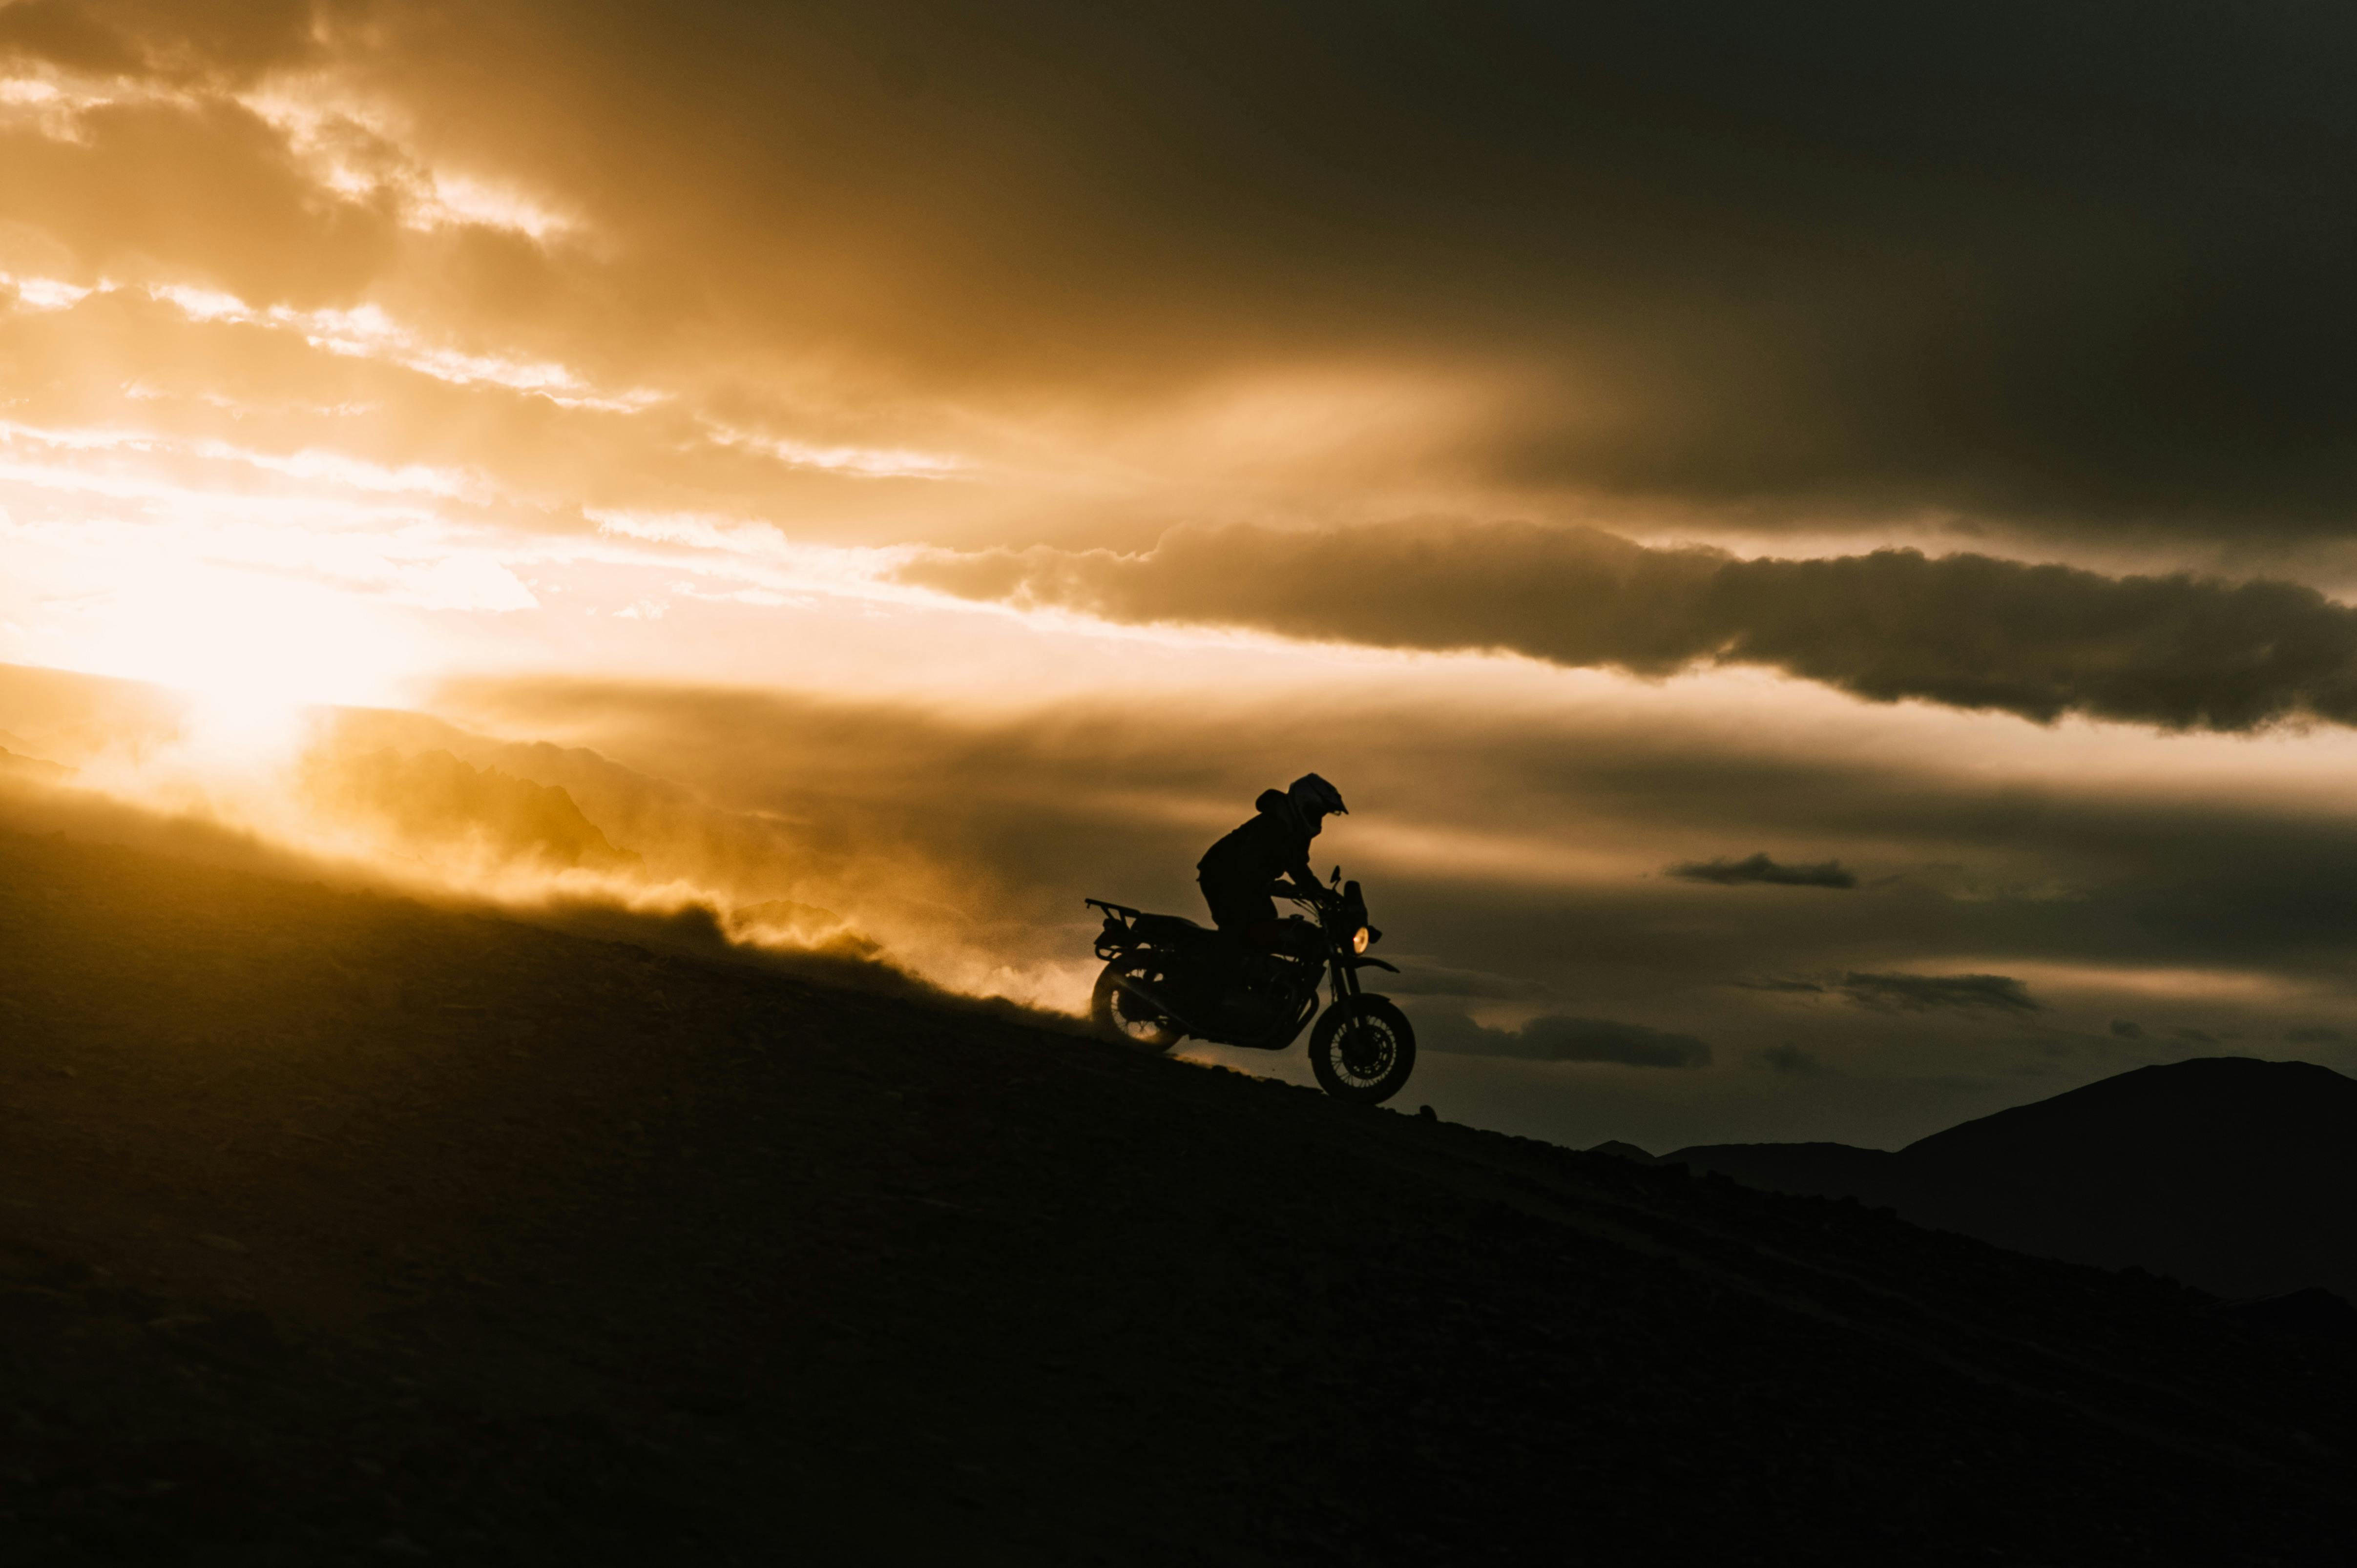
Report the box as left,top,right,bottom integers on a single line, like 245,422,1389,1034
14,0,2357,533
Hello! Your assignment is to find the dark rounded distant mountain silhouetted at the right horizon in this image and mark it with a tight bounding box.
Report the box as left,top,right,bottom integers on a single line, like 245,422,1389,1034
1662,1056,2357,1299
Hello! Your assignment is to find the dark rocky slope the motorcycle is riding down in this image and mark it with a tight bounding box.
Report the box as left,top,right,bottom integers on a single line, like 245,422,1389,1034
0,835,2357,1563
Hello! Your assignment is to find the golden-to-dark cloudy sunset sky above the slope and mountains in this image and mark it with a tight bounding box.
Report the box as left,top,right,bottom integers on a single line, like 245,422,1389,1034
0,0,2357,1148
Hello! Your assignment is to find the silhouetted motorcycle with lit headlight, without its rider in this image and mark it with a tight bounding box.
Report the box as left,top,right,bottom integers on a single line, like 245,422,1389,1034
1084,866,1417,1106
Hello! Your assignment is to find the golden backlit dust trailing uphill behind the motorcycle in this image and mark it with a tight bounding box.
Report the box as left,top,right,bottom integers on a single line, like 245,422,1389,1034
0,667,1086,1007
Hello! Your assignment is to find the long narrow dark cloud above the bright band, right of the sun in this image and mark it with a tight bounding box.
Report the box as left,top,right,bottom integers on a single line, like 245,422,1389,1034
900,523,2357,731
